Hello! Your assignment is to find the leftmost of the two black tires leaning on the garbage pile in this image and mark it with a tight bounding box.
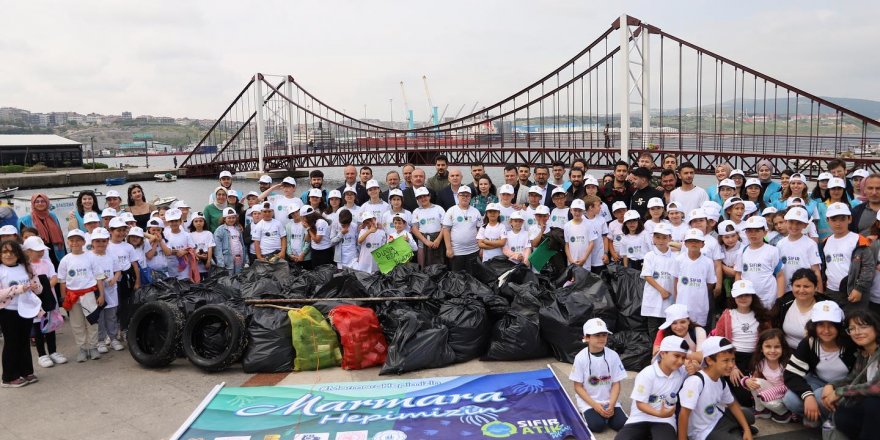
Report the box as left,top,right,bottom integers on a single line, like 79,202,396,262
128,301,184,368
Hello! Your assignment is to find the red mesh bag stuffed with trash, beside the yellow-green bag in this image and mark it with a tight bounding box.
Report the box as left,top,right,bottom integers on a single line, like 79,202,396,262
329,305,388,370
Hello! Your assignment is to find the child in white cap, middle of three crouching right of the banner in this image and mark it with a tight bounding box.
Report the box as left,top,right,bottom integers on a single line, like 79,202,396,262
615,336,688,440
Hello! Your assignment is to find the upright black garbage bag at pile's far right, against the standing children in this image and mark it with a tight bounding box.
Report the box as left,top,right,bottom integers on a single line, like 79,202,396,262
602,264,648,332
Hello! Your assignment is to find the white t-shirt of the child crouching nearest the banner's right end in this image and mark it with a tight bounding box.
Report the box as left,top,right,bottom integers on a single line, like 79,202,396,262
568,347,626,412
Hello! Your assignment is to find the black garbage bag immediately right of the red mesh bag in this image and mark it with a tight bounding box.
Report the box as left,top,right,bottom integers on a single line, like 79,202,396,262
379,311,455,375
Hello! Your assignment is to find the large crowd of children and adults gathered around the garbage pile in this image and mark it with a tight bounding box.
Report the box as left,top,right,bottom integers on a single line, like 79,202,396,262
0,153,880,439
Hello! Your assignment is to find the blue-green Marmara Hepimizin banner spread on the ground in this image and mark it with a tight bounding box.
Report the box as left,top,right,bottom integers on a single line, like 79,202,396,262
172,368,590,440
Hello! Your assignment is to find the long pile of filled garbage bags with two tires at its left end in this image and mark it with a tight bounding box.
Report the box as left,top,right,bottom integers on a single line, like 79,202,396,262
130,257,651,374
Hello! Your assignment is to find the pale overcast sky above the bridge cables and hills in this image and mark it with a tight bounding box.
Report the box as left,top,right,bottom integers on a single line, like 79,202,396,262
0,0,880,120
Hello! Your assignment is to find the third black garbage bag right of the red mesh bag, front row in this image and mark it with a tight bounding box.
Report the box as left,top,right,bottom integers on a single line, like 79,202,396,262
482,292,549,361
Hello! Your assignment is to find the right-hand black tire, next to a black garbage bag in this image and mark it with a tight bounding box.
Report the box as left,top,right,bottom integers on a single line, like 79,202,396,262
183,304,247,372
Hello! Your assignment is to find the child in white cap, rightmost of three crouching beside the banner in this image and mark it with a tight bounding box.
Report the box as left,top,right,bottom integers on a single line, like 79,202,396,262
678,336,755,440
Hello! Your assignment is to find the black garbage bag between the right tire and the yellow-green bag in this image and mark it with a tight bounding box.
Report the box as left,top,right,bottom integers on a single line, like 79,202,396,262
241,307,294,373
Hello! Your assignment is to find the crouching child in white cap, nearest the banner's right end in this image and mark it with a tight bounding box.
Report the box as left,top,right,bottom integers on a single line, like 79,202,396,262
568,318,627,433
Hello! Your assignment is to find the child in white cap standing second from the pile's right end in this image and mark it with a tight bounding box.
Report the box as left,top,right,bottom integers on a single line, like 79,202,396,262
675,229,718,327
